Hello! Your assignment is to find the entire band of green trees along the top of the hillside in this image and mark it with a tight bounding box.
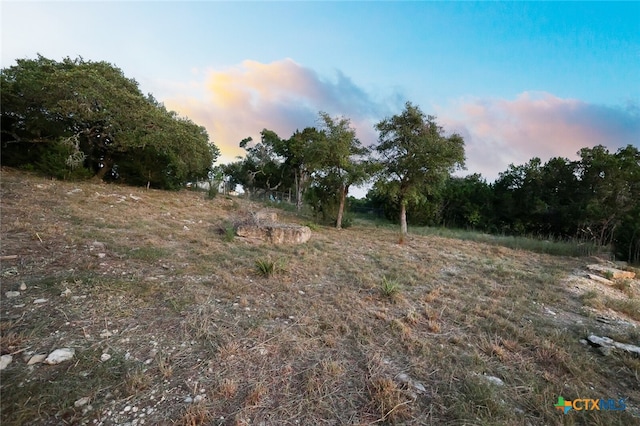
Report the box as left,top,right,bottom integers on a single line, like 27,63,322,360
0,56,640,262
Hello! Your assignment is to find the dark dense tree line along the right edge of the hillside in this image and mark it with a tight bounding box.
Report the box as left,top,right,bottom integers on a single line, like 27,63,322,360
362,145,640,263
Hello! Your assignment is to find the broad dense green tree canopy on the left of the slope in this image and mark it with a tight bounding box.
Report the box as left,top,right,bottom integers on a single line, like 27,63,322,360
0,56,219,188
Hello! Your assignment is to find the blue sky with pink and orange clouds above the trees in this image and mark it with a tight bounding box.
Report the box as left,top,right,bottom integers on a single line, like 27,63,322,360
0,0,640,191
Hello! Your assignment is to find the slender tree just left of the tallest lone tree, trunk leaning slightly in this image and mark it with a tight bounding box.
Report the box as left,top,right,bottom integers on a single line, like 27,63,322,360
307,112,370,229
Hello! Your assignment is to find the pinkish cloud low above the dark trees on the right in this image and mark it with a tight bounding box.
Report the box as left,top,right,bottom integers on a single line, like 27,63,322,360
439,92,640,181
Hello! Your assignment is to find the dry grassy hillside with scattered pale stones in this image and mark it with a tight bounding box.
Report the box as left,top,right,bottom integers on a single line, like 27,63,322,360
0,169,640,425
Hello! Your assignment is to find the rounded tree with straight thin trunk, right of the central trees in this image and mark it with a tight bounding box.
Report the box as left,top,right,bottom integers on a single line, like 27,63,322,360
375,102,465,238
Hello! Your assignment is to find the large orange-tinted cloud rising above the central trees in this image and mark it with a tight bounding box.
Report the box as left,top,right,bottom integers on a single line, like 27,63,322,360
163,59,396,162
